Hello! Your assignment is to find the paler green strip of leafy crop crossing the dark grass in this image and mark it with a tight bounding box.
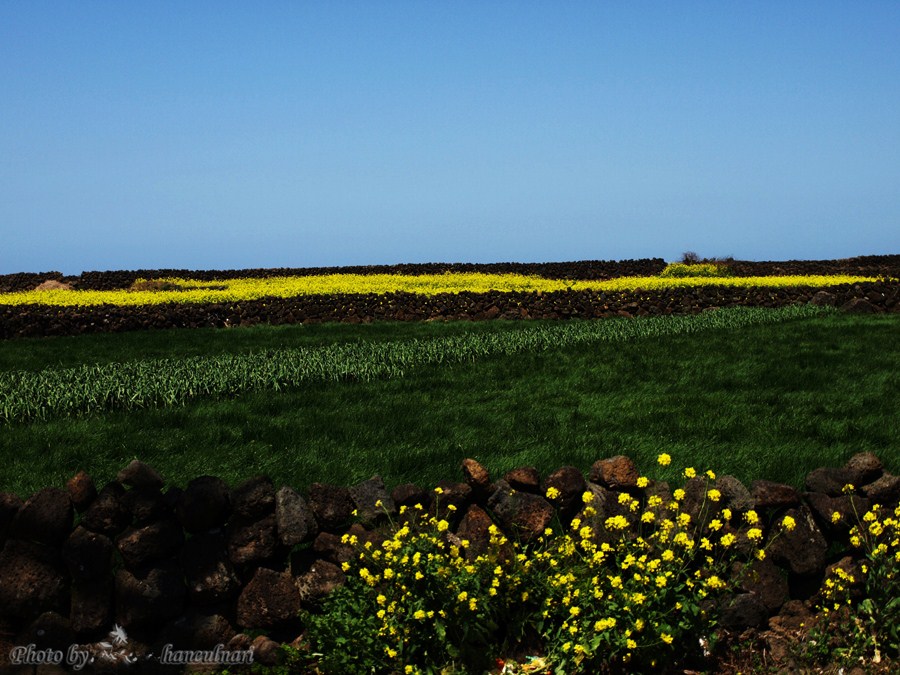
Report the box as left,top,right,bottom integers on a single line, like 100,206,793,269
0,305,826,424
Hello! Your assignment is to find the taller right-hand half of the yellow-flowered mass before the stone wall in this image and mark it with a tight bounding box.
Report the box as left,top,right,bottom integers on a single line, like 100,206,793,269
532,460,762,672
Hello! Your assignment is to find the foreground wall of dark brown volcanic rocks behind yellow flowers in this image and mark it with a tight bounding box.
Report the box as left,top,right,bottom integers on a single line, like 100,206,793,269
0,453,900,672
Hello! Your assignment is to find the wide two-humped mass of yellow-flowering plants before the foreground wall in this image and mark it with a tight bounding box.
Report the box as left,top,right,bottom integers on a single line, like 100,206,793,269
314,454,816,672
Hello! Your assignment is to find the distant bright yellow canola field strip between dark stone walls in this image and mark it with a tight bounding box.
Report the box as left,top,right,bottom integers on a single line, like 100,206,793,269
0,273,878,306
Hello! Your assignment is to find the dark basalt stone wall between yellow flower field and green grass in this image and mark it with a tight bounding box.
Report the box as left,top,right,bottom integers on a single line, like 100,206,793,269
0,281,900,339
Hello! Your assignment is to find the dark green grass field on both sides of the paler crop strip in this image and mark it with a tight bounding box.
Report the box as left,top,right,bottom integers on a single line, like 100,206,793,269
0,314,900,496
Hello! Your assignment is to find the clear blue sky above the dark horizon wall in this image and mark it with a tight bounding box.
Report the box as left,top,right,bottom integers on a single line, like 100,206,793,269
0,0,900,274
